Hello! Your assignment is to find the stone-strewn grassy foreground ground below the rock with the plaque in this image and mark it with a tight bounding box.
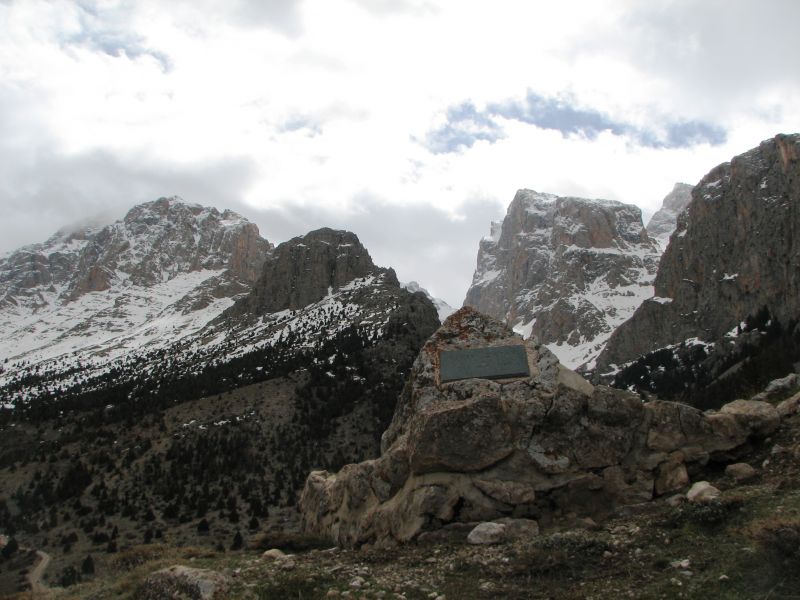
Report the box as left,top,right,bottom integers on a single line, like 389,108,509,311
3,406,800,600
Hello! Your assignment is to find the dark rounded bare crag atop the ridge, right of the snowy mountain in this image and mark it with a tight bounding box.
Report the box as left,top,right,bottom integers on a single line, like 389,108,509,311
227,228,384,316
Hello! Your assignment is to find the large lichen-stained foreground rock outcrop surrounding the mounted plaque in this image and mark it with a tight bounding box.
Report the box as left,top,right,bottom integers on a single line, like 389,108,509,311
300,308,778,546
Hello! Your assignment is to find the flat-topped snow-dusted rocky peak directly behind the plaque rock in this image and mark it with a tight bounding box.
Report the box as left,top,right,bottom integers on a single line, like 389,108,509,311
464,190,659,368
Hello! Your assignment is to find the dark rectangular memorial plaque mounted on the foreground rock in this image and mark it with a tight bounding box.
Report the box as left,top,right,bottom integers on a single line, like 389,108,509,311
439,345,530,383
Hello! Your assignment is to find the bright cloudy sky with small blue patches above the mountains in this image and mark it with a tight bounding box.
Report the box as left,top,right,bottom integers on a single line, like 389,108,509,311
0,0,800,306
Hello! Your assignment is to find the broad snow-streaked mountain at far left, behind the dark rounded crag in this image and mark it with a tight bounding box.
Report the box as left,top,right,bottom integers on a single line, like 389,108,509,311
0,198,270,362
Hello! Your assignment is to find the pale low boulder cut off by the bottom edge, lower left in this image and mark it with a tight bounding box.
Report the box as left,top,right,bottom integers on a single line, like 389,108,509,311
134,565,230,600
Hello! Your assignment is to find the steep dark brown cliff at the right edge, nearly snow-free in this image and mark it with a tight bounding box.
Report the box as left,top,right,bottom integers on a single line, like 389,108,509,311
597,134,800,373
